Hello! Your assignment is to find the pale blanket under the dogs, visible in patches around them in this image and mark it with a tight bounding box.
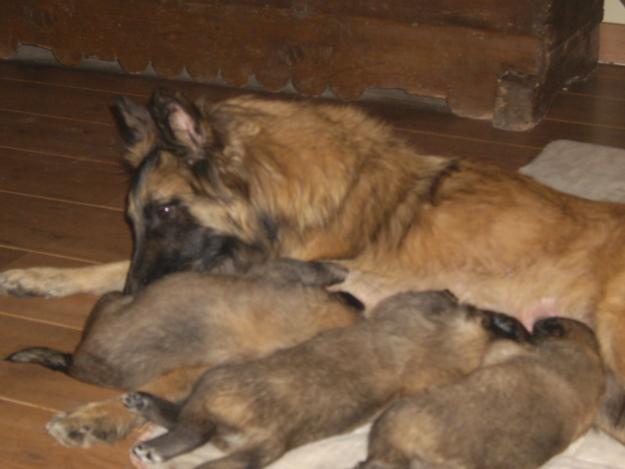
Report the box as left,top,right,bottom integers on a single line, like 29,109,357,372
140,140,625,469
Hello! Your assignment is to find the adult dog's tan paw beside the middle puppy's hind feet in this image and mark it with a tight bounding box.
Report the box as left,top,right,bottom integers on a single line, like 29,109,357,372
46,400,138,448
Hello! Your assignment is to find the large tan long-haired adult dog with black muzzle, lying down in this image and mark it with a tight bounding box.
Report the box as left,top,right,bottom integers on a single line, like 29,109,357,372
0,92,625,441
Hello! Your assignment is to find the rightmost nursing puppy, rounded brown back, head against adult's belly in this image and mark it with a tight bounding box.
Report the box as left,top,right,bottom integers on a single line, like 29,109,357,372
358,318,604,469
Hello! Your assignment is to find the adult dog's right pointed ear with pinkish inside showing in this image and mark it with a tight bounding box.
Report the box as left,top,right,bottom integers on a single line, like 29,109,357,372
150,89,210,163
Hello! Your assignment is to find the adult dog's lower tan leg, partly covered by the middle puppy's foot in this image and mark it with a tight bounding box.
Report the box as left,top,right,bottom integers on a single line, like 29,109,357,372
46,366,206,448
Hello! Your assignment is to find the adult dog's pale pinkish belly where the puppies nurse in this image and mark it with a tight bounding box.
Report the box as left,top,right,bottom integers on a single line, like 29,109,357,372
334,271,595,330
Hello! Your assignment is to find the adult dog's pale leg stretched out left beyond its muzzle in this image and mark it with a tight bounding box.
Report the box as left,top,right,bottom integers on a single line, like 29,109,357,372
0,261,130,297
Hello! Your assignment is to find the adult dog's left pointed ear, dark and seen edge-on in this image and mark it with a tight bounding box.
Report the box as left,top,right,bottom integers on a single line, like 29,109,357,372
111,97,157,168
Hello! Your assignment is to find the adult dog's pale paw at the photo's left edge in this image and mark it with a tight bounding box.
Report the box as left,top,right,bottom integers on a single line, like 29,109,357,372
0,267,67,297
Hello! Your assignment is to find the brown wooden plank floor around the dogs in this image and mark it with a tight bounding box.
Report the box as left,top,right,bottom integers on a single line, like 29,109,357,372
0,62,625,469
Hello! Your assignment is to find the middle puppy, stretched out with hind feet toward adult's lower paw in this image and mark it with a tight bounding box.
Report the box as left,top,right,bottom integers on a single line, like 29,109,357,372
125,292,528,469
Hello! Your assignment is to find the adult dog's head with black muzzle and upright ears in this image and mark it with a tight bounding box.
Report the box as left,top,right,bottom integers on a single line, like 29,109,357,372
113,91,273,292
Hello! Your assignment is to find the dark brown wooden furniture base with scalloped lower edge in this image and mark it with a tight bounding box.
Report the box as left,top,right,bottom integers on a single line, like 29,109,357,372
0,0,599,129
